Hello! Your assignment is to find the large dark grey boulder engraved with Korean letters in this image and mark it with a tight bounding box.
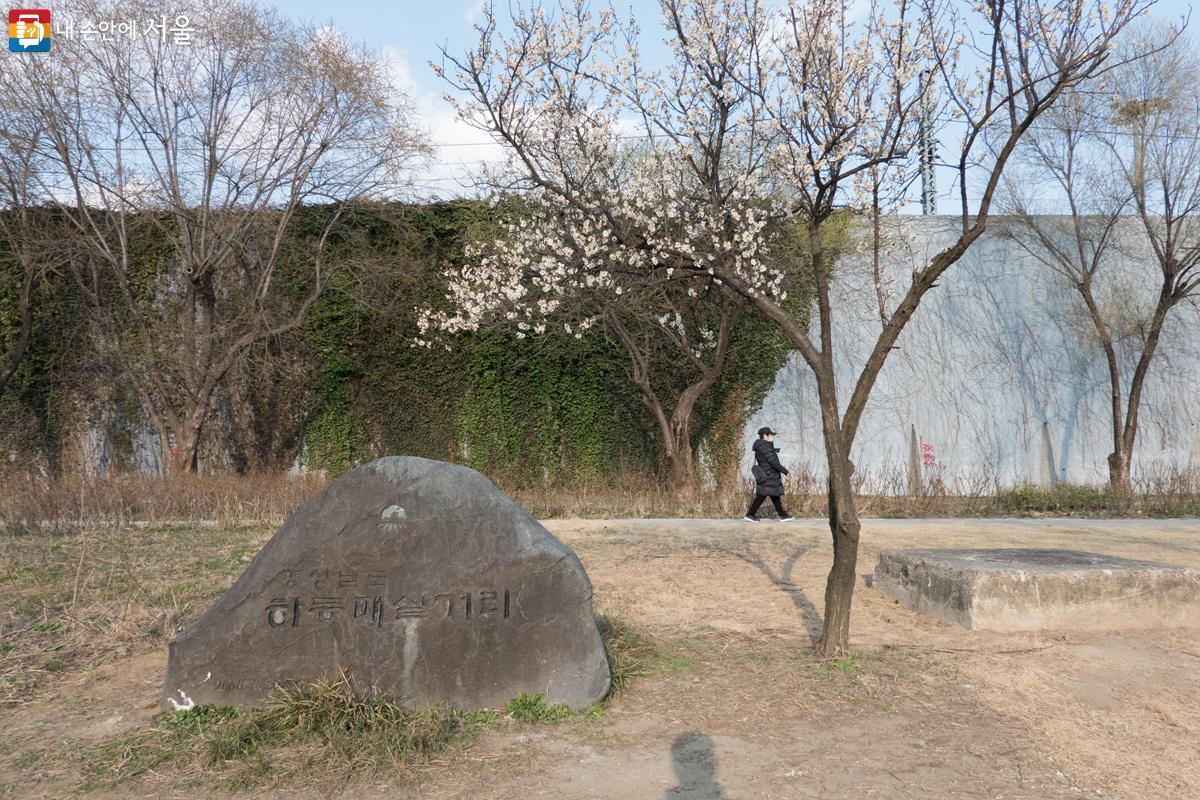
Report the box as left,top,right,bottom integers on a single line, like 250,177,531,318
161,457,610,709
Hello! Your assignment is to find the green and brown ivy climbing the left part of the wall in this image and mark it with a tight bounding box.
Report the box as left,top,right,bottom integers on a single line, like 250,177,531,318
0,200,844,486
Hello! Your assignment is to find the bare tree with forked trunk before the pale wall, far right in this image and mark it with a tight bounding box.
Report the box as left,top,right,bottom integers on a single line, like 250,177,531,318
1008,28,1200,493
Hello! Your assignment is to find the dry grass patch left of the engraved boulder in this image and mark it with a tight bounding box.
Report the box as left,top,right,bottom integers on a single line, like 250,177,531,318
0,527,270,705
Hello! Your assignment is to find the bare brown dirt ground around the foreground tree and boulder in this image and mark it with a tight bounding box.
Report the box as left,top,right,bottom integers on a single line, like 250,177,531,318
0,519,1200,800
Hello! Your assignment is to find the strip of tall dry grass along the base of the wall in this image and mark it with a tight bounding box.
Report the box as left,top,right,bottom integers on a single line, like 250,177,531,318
0,469,1200,534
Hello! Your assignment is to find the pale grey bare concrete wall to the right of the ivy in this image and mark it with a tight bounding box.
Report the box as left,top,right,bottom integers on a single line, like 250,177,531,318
743,217,1200,493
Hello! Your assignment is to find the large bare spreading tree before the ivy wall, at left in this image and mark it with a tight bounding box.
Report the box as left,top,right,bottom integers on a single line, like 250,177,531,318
20,0,425,473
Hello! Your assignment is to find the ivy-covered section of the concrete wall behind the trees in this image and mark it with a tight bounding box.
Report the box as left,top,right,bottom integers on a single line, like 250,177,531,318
0,200,787,486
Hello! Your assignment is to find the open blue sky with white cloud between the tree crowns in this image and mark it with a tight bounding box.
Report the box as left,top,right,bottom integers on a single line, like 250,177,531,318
275,0,1200,197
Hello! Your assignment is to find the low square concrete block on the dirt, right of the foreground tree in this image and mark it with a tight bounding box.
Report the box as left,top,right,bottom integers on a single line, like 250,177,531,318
874,548,1200,631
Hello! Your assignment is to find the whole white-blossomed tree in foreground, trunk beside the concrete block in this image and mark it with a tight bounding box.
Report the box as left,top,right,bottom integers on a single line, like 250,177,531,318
427,0,1153,655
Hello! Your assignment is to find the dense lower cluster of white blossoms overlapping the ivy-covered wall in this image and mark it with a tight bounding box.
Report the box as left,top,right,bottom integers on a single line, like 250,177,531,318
418,161,786,349
